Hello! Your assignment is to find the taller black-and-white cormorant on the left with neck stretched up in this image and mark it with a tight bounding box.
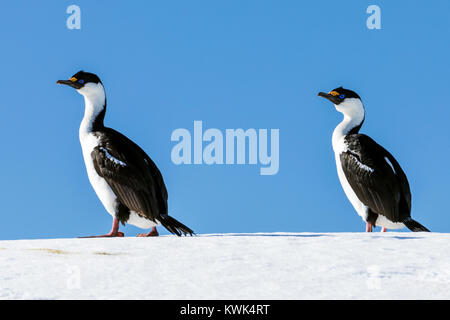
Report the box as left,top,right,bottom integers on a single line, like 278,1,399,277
56,71,193,237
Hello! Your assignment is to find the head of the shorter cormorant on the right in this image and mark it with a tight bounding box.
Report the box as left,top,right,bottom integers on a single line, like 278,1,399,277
318,87,364,117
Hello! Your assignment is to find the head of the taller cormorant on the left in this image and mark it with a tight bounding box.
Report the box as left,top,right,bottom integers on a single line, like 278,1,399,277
56,71,105,97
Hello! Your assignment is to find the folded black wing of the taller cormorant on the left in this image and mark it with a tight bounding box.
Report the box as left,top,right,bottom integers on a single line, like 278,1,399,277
91,128,168,221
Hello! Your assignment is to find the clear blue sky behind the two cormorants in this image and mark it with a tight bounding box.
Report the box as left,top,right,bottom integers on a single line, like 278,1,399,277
0,0,450,239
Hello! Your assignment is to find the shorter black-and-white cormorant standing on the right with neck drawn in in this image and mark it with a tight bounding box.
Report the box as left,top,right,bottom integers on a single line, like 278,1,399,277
319,87,429,232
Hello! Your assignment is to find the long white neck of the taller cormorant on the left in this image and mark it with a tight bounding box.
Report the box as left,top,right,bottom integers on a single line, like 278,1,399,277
78,83,106,137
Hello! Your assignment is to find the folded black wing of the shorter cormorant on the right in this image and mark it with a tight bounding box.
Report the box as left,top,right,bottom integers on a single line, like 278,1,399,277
340,134,411,222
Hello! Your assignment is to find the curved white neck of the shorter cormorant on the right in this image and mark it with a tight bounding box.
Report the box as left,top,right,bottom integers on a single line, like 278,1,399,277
332,99,365,153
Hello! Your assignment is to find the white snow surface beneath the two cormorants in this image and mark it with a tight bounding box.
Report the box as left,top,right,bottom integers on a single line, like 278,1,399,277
0,232,450,299
